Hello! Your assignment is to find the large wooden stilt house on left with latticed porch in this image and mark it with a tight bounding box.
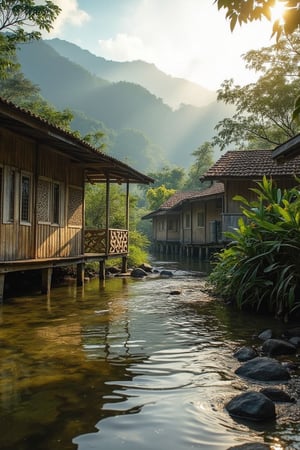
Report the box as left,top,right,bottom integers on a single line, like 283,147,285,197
0,98,153,298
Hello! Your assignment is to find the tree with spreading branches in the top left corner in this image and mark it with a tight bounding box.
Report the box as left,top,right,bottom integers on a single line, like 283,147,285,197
0,0,61,78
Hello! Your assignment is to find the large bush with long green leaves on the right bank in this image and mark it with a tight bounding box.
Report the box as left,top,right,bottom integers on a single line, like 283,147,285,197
209,177,300,316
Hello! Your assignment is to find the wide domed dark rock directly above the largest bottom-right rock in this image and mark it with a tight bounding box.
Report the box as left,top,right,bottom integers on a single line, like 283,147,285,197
235,356,290,381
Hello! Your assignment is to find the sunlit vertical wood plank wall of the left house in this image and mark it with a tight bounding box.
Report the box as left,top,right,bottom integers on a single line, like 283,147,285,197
0,129,84,261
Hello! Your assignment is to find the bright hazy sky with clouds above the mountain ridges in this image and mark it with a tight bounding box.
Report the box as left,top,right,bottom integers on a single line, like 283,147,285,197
43,0,275,90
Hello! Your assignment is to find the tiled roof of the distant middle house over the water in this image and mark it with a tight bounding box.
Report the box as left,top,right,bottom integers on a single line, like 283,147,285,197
143,183,224,219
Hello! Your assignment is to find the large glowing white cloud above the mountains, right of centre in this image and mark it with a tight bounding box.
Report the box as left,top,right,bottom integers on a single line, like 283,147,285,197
97,0,270,89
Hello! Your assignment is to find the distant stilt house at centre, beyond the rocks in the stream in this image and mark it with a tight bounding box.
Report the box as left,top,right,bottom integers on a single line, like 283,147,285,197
143,183,224,259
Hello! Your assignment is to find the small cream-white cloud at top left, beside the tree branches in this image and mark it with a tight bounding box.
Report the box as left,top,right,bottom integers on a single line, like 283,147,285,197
47,0,90,37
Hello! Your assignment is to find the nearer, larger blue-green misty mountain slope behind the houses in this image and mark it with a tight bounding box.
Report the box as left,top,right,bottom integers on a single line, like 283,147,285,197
18,41,231,172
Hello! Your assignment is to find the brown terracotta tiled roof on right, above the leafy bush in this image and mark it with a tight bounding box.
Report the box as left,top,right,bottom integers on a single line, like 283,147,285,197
203,150,300,180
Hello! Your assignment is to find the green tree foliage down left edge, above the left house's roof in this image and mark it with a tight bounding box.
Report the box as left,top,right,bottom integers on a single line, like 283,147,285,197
0,0,73,131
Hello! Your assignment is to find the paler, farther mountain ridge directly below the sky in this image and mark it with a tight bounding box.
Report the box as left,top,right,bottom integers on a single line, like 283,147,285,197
45,39,216,109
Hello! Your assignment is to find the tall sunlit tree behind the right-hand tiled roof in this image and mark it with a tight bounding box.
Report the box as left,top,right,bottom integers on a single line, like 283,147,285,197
213,32,300,149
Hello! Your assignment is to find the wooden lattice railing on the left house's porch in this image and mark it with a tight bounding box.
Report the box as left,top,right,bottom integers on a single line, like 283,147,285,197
84,228,128,256
